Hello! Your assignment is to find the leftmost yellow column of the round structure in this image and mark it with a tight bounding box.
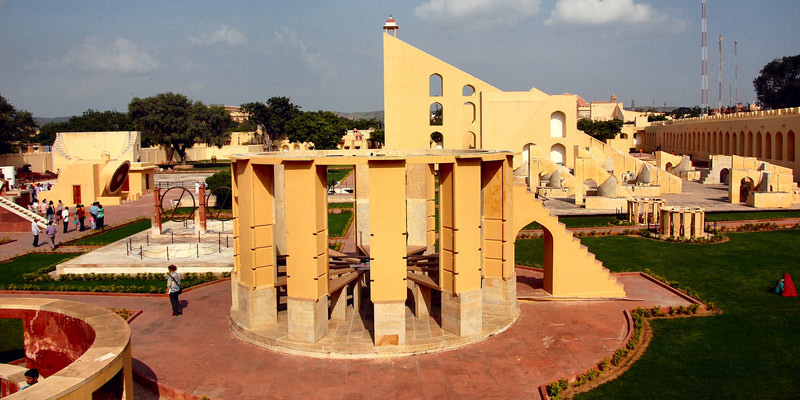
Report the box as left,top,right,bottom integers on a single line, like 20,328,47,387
231,161,278,330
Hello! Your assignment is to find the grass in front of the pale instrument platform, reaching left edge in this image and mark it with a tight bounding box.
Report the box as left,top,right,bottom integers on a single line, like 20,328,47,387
0,253,213,293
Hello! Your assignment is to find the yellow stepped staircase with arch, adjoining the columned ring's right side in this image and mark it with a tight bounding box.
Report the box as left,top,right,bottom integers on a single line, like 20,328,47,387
514,183,626,298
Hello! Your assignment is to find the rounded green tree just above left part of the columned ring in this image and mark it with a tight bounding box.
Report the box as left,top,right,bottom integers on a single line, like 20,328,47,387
286,111,347,150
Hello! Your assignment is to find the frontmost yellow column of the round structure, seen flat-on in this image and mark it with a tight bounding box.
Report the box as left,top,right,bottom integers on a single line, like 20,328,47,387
368,160,407,346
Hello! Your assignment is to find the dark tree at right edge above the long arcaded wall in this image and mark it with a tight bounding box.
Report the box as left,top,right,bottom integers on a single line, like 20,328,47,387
753,55,800,108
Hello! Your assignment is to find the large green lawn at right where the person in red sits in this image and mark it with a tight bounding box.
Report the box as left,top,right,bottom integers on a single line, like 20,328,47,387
516,230,800,399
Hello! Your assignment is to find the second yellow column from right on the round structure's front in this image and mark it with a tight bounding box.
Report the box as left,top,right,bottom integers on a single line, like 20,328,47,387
439,158,483,336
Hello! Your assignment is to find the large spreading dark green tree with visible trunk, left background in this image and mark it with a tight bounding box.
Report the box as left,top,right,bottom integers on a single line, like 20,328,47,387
128,92,232,164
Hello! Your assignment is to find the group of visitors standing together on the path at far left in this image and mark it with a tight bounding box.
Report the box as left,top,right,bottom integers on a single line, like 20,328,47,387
31,199,106,249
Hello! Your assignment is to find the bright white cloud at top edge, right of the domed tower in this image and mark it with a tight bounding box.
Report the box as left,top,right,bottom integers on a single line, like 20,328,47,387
544,0,653,25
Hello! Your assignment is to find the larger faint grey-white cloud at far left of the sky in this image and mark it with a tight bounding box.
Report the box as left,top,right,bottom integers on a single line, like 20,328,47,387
63,36,158,74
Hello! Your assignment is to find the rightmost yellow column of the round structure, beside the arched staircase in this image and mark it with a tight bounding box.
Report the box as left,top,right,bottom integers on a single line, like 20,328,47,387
481,155,517,316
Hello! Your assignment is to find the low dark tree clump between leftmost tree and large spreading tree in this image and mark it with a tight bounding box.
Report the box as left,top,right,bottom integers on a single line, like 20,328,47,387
33,109,134,145
